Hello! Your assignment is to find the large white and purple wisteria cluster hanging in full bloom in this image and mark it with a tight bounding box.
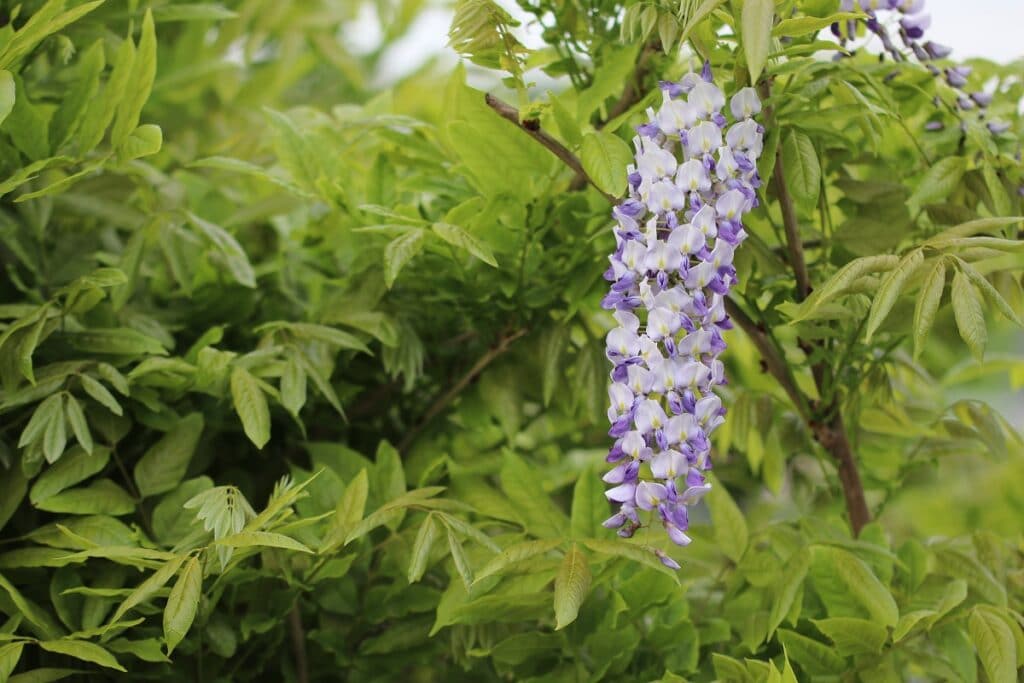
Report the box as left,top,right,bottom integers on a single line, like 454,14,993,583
603,65,764,568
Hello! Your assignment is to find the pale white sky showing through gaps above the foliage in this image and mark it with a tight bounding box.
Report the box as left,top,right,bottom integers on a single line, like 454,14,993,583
354,0,1024,82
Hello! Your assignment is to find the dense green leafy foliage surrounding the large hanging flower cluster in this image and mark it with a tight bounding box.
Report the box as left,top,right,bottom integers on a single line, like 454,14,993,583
0,0,1024,683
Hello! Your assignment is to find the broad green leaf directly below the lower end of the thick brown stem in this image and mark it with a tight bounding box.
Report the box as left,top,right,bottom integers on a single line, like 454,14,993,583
811,546,899,627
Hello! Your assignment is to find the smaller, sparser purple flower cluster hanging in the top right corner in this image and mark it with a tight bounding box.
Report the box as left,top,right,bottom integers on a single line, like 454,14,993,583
831,0,1010,135
